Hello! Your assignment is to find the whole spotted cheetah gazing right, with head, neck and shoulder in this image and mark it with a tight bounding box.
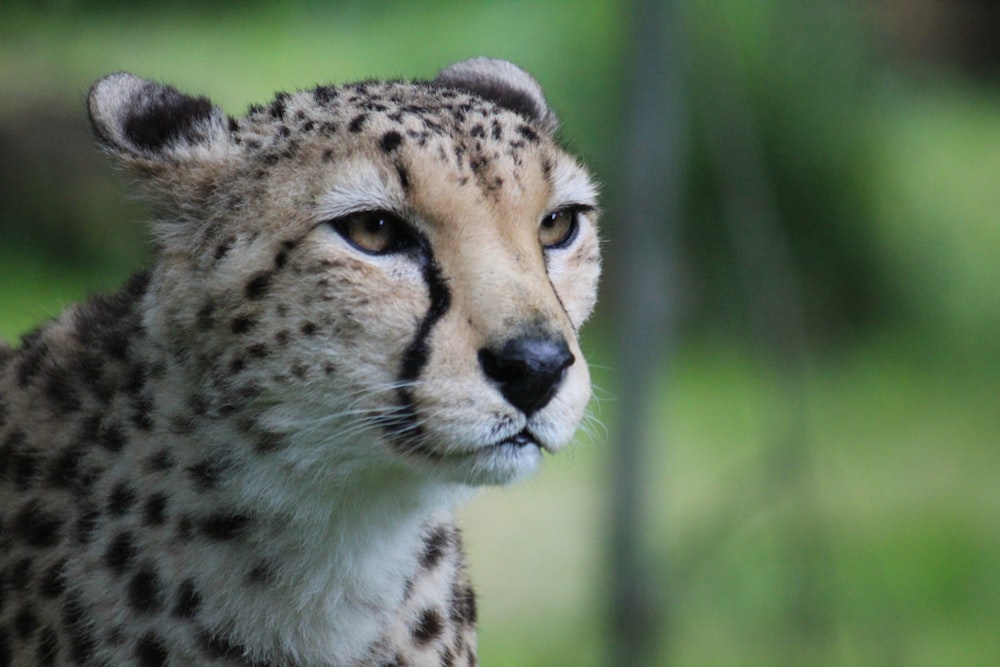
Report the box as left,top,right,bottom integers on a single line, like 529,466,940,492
0,58,600,667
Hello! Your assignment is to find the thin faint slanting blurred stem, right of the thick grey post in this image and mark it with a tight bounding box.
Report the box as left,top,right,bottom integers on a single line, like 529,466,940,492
698,18,834,665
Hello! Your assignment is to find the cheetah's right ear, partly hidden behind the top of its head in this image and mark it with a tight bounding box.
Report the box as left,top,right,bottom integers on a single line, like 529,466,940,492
434,58,559,135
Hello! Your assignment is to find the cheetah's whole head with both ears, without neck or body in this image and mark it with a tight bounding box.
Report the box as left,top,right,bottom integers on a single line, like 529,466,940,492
90,59,600,484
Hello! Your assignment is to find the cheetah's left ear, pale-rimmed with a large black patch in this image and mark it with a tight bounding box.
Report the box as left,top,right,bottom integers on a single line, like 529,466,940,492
87,72,228,167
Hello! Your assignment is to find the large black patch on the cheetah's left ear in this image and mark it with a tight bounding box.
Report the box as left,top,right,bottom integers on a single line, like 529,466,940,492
113,84,213,151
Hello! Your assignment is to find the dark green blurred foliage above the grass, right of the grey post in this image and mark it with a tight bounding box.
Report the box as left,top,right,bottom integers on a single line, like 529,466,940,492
682,0,895,339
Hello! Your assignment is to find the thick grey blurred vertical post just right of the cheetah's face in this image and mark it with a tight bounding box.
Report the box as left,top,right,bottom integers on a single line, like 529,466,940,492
609,0,685,666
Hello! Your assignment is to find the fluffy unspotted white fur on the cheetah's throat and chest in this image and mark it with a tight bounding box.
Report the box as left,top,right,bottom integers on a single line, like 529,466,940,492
203,426,470,665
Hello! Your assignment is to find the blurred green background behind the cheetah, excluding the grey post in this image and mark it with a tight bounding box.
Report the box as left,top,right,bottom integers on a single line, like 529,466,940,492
0,0,1000,667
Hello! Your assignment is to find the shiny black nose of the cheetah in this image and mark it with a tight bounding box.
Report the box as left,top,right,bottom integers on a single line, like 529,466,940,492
479,336,575,417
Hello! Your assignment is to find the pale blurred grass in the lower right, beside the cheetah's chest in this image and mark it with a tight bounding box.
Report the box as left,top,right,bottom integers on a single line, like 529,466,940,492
464,336,1000,667
